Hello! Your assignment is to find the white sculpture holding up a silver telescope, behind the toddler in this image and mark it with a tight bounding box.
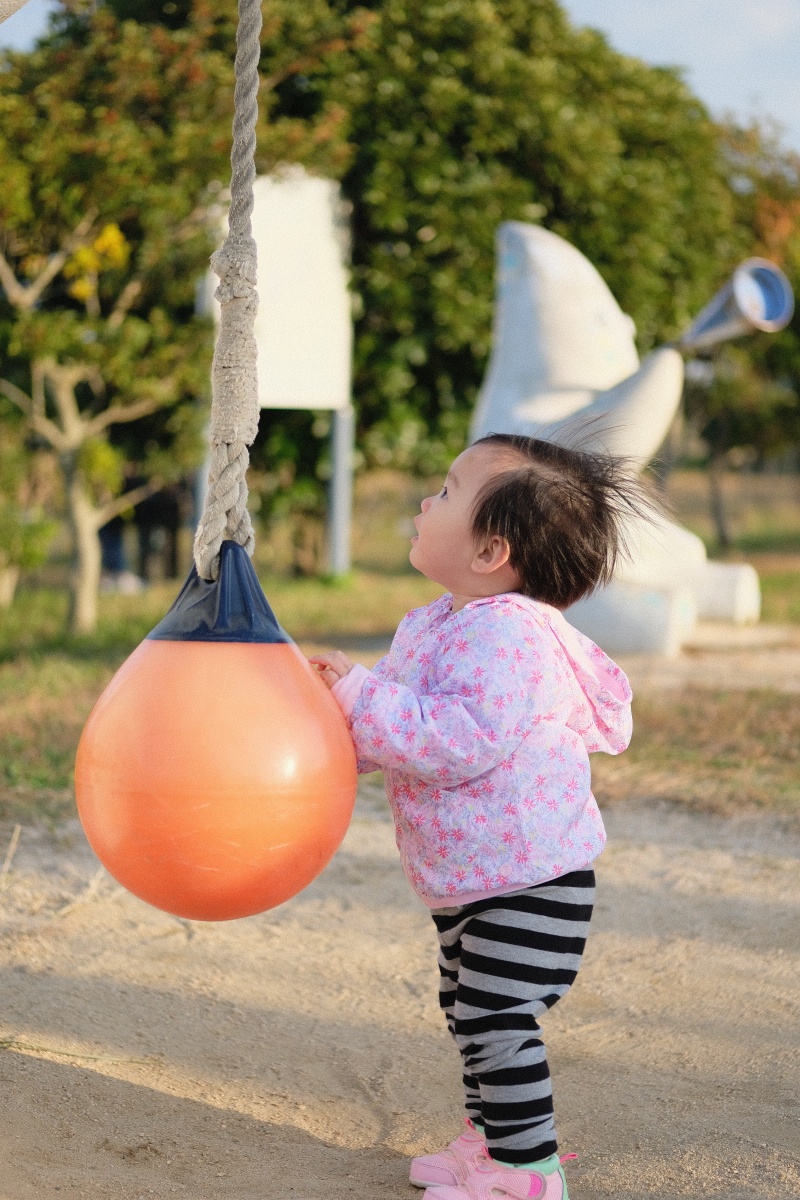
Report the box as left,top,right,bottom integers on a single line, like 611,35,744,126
471,221,793,654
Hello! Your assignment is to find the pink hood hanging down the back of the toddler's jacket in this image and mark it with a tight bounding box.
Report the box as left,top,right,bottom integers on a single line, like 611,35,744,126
513,594,632,754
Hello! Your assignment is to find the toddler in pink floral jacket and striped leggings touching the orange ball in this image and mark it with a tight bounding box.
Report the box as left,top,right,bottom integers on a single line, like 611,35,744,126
311,434,649,1200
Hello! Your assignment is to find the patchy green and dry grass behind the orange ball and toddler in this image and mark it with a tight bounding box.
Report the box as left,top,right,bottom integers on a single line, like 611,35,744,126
0,473,800,822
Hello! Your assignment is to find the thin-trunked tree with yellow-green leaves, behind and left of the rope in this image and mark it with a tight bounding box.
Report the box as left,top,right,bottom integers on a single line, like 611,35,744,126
0,0,359,631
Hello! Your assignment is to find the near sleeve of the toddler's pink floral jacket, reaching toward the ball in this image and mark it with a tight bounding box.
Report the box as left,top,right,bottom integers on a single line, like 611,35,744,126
333,610,536,786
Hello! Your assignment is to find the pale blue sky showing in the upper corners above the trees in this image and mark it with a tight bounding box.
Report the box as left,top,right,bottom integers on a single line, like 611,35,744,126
0,0,800,151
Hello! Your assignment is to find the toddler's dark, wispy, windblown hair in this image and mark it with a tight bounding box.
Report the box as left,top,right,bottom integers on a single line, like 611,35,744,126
473,433,658,608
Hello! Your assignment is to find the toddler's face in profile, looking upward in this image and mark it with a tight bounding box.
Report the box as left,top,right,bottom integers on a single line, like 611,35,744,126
409,446,517,596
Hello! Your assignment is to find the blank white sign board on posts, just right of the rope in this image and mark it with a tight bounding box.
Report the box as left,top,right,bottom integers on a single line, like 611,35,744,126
253,168,353,408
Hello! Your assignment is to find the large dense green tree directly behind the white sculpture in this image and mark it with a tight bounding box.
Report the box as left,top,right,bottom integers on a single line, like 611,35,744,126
314,0,739,463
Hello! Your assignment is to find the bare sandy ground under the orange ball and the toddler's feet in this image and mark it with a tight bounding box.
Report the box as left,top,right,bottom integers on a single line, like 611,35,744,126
0,633,800,1200
